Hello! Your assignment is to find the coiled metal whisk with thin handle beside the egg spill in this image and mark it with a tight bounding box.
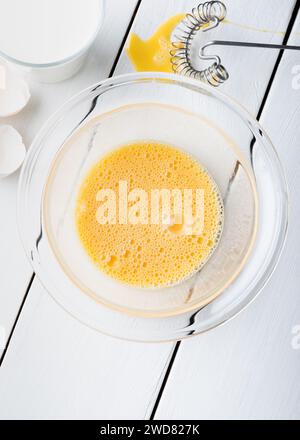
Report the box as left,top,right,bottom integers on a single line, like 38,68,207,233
170,1,300,87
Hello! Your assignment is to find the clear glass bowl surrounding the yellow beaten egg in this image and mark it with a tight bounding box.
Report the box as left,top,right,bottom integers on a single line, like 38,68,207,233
18,73,287,341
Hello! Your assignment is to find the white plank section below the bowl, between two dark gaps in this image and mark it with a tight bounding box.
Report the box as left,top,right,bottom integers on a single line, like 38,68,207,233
0,282,170,419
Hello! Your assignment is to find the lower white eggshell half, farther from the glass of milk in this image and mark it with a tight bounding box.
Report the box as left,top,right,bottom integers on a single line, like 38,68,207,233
0,125,26,178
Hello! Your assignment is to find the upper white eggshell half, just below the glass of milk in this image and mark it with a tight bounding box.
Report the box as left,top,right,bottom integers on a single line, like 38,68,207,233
0,62,30,118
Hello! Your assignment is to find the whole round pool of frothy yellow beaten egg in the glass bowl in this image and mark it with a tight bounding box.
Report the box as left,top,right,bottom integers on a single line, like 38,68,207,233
75,141,224,288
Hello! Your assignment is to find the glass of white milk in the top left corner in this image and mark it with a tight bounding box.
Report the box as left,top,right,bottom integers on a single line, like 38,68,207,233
0,0,104,82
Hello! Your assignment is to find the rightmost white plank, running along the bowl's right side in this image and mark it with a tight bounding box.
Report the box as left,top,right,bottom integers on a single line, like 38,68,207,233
156,6,300,420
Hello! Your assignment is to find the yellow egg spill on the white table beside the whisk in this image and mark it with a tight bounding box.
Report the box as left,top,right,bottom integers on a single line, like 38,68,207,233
126,14,186,73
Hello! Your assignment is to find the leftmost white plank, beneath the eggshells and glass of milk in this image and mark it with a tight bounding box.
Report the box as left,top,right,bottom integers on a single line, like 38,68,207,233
0,0,137,348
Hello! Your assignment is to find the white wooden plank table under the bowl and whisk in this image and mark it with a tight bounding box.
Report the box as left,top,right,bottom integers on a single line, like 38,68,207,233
0,0,300,420
